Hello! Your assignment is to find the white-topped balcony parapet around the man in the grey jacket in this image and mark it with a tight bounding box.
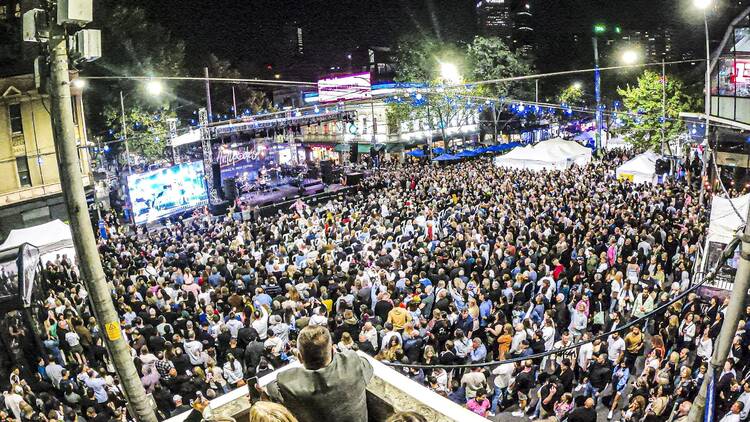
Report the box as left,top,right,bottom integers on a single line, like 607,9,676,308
166,352,486,422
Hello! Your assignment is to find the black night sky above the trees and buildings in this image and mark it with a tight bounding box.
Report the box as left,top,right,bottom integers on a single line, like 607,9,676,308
131,0,730,76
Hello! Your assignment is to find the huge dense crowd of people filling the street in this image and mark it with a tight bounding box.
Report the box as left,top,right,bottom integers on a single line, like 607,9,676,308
0,151,750,422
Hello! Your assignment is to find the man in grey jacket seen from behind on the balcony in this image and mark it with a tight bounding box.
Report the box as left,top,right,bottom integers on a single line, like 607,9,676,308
267,325,373,422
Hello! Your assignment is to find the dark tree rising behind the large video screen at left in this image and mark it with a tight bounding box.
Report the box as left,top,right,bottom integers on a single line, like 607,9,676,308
84,1,185,162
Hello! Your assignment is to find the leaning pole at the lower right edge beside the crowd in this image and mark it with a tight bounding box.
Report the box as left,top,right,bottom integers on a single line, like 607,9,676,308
688,216,750,422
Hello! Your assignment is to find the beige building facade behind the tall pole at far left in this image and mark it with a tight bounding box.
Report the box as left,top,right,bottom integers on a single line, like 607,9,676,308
0,75,91,238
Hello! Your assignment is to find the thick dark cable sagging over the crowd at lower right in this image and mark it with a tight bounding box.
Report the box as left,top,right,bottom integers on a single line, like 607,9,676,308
382,236,740,369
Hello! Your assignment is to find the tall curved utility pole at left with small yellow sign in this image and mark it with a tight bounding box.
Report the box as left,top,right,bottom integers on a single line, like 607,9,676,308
49,14,156,422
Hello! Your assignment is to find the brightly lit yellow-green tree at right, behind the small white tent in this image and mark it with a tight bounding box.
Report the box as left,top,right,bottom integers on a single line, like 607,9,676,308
617,70,697,149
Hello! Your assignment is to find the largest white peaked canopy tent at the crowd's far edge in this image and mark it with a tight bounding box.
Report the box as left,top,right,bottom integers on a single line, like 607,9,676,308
495,138,591,170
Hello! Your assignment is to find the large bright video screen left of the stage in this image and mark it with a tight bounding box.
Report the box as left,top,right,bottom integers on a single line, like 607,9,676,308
128,161,208,224
